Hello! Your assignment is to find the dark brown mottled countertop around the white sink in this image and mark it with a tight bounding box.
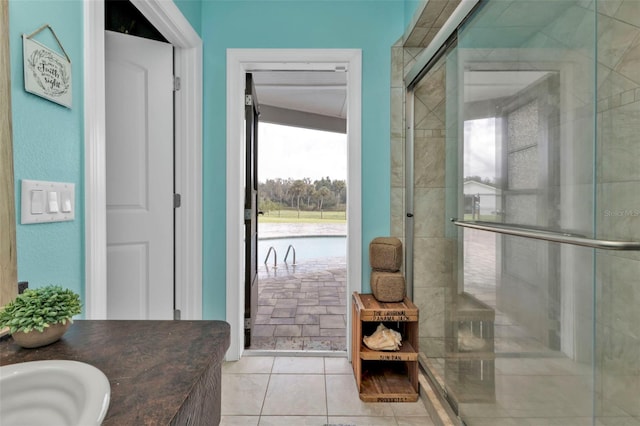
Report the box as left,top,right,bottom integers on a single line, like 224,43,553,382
0,320,230,426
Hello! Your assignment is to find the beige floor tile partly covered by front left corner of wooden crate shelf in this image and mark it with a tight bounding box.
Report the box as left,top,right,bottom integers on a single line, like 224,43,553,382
325,374,393,417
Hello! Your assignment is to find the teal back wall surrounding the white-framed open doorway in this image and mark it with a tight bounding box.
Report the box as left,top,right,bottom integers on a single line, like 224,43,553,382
202,0,404,319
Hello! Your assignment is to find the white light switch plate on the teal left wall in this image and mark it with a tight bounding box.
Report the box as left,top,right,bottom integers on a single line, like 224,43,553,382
20,179,76,225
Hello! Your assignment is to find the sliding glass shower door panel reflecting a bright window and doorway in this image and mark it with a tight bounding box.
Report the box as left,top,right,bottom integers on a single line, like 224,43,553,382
452,1,595,416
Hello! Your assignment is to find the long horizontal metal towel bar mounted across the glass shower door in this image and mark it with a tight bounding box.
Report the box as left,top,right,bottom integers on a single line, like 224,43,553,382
451,218,640,250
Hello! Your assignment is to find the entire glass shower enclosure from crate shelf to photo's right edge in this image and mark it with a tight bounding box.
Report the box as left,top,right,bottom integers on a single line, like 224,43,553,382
407,0,640,426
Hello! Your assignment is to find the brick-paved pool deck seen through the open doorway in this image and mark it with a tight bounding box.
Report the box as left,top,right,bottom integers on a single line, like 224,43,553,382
249,257,347,351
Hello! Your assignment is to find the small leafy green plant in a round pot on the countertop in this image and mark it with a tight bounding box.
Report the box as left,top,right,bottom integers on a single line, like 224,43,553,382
0,285,81,348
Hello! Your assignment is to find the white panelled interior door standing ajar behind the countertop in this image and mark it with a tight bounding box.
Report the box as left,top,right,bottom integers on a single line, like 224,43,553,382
105,31,174,319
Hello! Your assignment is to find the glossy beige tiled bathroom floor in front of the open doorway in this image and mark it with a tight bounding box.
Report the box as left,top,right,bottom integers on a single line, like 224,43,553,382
220,356,434,426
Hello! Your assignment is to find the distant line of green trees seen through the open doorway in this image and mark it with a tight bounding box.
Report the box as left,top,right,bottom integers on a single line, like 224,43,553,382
258,176,347,212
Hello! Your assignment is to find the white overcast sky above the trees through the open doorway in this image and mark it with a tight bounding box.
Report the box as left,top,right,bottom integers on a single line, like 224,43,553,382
258,123,347,182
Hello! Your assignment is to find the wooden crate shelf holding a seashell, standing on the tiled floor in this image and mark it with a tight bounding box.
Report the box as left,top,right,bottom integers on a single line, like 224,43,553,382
351,292,419,402
